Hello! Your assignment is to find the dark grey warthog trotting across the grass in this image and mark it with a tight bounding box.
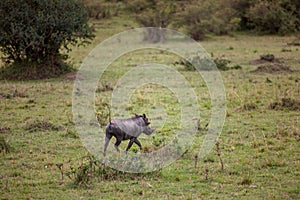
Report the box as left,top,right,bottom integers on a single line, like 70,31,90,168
103,114,154,156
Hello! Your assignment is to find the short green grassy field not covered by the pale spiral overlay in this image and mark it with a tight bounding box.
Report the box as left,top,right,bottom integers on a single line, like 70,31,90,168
0,18,300,199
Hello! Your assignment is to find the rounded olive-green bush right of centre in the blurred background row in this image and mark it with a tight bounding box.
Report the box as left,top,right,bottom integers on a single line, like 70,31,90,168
176,0,240,40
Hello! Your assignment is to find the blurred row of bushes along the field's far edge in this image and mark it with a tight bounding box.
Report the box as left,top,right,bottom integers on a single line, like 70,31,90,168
83,0,300,40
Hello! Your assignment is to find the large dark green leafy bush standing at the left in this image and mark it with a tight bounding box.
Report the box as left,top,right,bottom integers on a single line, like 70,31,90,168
0,0,93,78
